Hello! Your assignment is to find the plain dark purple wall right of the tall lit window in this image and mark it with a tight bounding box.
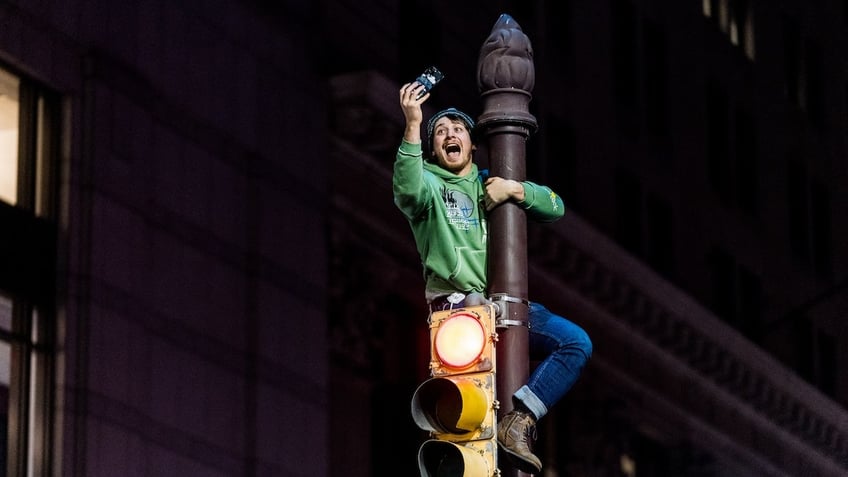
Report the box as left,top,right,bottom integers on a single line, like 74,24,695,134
0,1,328,476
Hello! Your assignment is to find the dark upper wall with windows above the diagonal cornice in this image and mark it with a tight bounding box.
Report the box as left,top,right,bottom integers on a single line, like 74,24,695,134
510,0,848,405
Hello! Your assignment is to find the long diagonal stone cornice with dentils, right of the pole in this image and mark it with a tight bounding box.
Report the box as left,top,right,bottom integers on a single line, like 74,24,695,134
529,213,848,475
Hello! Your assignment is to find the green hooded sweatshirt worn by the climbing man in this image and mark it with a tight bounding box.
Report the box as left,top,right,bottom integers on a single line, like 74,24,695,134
392,141,565,300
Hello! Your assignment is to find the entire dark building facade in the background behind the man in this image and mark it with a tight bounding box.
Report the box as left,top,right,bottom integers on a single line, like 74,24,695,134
0,0,848,477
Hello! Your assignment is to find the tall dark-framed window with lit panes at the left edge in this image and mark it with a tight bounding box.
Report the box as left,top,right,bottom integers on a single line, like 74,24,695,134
0,64,59,477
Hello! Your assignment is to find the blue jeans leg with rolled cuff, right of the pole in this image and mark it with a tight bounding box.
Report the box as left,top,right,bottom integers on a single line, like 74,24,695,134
513,302,592,419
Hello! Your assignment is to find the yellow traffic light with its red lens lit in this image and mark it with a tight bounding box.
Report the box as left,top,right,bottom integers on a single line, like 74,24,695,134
412,305,500,477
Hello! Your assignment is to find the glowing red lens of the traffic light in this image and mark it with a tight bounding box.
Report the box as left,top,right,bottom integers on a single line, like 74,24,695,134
433,313,486,369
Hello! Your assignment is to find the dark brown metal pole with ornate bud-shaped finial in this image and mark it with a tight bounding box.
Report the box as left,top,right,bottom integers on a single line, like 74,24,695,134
477,14,537,477
